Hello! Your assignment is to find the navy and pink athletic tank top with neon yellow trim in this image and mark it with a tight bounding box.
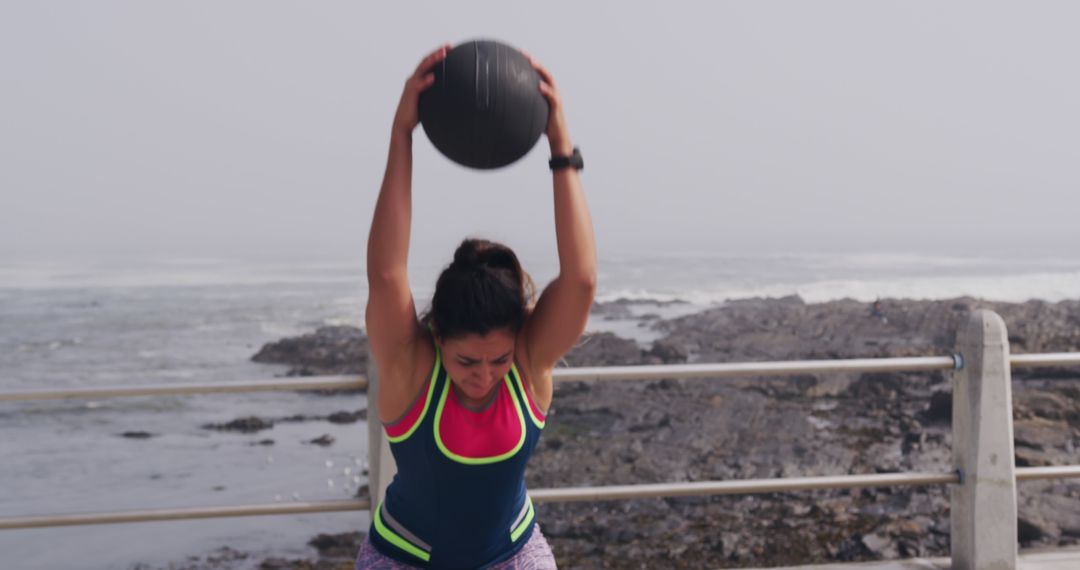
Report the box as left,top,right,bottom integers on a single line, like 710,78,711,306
369,345,544,569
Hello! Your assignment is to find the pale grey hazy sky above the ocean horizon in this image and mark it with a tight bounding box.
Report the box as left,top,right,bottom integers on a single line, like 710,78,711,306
0,0,1080,267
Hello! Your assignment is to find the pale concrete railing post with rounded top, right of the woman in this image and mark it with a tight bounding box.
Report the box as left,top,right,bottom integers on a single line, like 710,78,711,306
950,310,1017,570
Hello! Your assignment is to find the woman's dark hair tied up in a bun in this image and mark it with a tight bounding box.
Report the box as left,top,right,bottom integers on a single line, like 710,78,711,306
422,239,535,338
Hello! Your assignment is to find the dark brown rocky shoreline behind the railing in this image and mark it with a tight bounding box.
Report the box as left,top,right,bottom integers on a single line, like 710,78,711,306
154,297,1080,569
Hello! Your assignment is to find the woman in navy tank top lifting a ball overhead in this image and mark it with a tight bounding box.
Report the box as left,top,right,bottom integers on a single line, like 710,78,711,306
356,45,596,569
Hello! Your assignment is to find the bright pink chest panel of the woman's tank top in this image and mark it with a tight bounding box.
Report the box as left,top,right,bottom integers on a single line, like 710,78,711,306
435,379,525,463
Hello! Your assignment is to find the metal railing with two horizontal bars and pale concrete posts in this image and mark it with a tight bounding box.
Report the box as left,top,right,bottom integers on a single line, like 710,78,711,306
0,311,1080,568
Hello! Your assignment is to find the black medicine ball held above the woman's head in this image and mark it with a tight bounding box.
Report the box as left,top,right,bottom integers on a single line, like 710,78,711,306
419,40,549,168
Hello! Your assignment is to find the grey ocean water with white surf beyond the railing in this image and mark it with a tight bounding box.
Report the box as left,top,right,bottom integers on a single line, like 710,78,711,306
0,252,1080,570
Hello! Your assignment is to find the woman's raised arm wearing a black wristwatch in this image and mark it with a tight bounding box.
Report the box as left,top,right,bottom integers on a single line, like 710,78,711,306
525,57,596,377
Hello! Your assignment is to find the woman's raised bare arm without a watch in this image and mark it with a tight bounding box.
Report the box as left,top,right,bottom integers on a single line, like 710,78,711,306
365,45,449,410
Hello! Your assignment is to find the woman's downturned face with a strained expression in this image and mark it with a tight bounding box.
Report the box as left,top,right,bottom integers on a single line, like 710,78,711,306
438,329,514,403
